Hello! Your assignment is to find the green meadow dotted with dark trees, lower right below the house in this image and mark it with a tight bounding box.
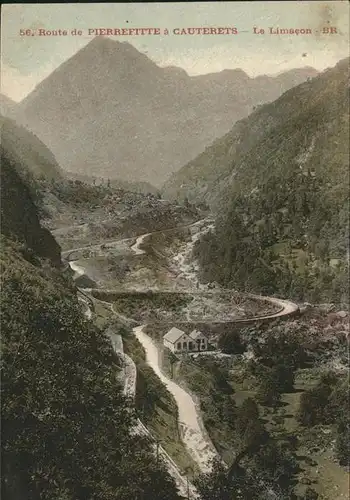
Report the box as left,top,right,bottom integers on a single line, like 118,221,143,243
174,322,349,500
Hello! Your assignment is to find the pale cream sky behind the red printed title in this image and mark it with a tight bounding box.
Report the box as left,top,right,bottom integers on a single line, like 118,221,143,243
1,1,349,101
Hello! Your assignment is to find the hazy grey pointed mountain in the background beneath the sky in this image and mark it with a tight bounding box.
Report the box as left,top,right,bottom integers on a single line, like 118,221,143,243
17,37,317,186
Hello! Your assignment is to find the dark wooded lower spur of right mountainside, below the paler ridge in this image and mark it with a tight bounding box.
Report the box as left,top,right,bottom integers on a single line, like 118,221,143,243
195,166,348,301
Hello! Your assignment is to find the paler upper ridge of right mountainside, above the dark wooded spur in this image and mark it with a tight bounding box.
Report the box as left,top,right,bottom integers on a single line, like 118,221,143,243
163,59,349,208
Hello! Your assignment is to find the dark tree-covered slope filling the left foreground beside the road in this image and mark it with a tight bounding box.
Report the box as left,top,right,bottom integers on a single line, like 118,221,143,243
0,146,179,500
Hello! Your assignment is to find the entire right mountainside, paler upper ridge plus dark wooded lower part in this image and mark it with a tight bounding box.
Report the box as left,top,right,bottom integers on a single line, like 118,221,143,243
185,56,349,303
